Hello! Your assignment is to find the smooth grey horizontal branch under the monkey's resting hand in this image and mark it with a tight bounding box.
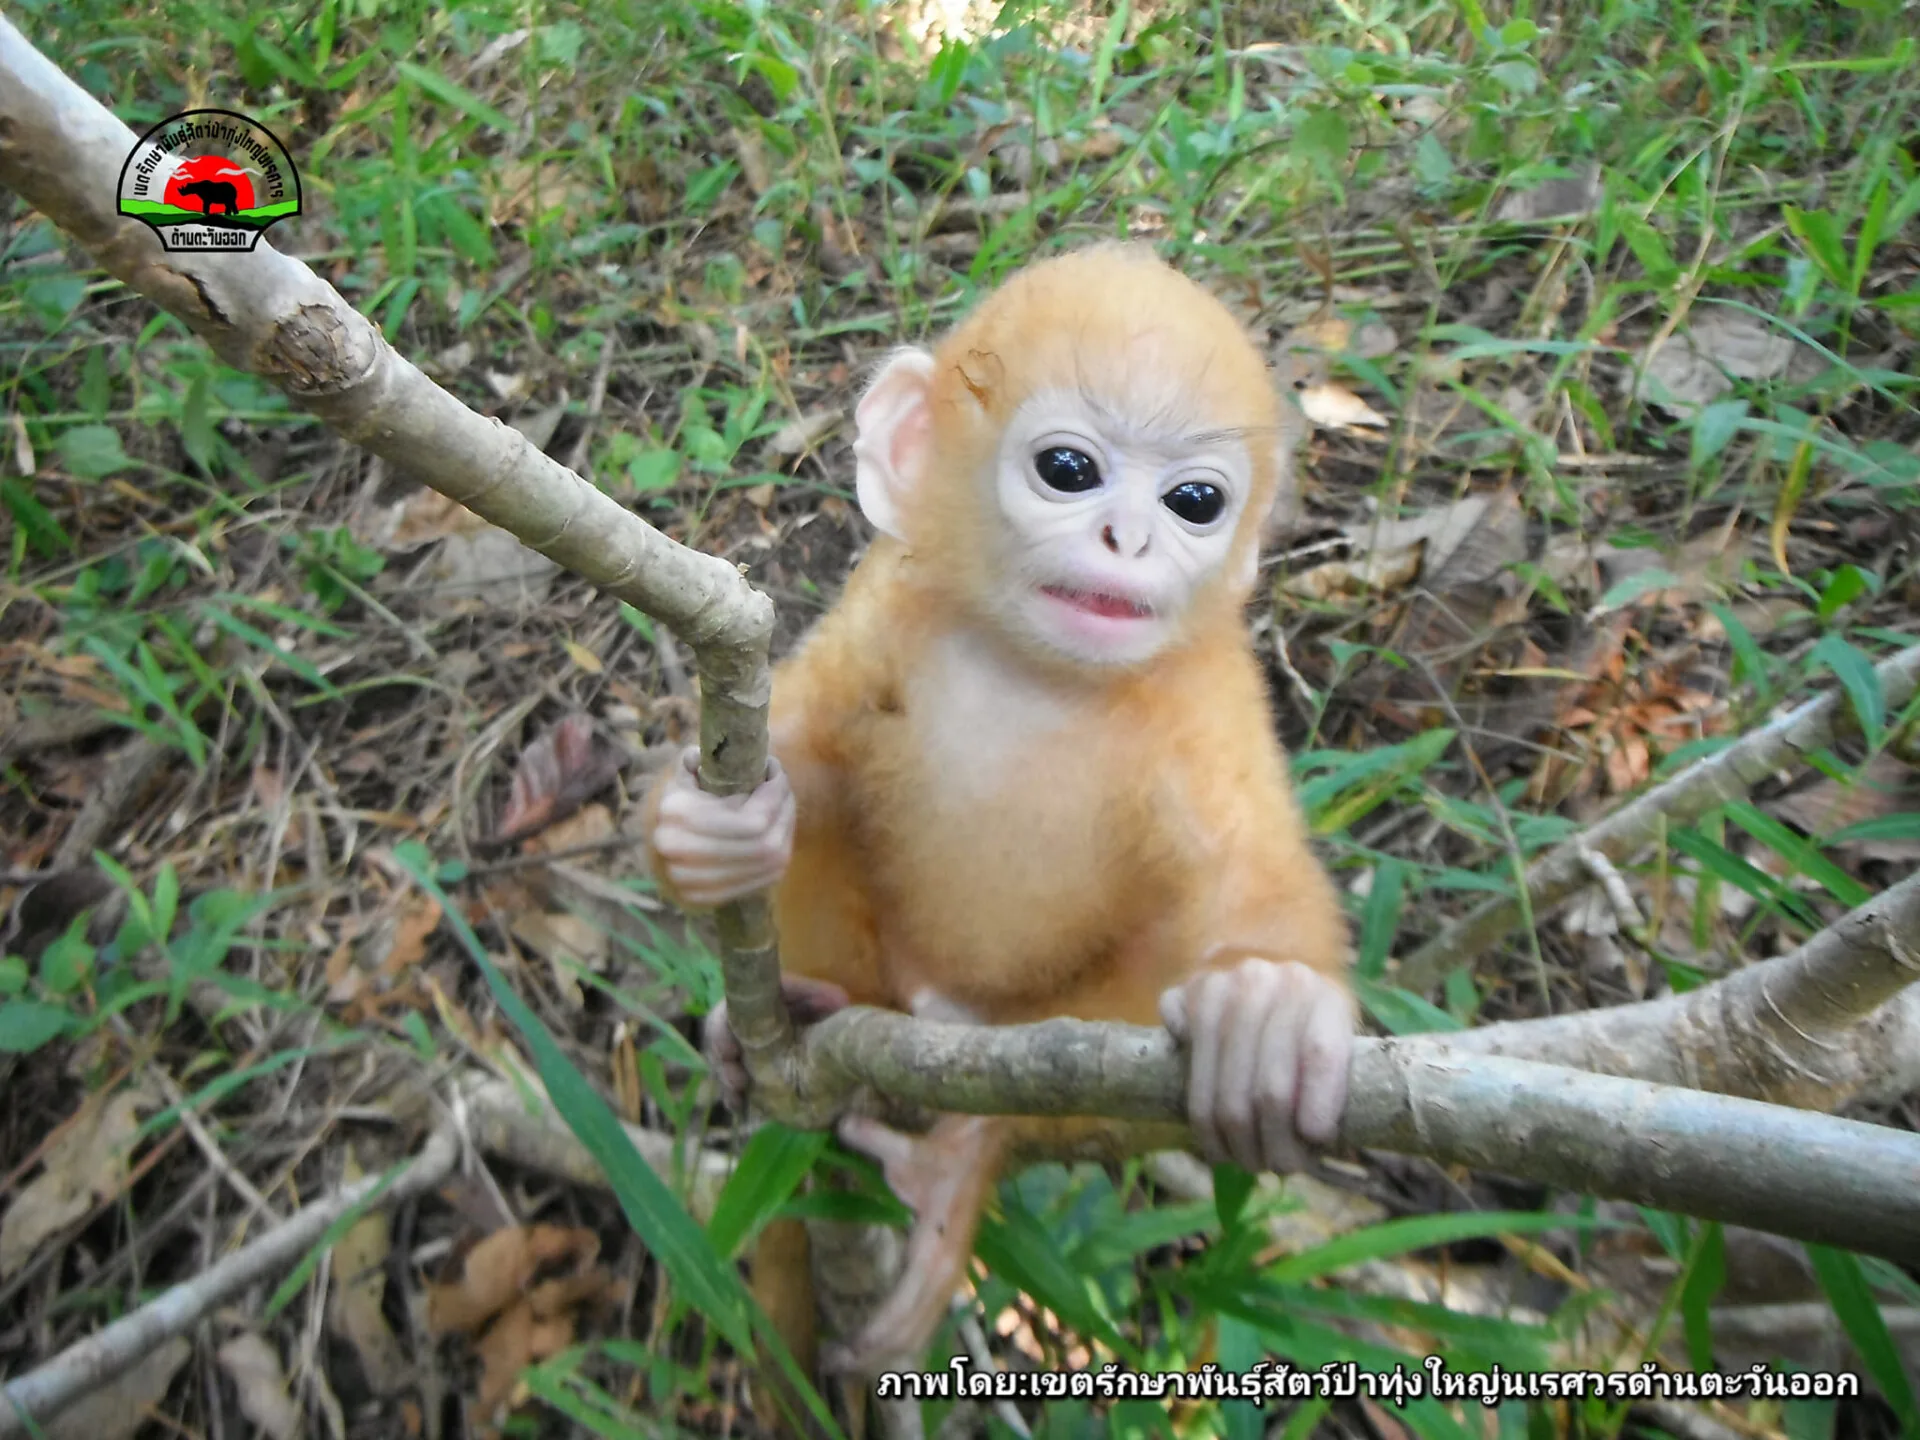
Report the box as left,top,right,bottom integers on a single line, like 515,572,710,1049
803,1008,1920,1263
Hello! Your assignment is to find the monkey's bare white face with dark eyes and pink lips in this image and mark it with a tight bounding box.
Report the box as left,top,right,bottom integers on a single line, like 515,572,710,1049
995,390,1252,664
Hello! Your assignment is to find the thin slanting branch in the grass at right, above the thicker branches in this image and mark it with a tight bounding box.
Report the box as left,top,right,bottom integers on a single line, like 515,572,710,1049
1392,645,1920,991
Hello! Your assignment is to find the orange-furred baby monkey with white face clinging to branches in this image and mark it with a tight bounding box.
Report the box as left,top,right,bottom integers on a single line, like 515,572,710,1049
649,246,1354,1373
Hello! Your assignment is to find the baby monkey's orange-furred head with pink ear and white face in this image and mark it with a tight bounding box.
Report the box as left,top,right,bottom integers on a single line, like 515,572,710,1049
854,244,1290,670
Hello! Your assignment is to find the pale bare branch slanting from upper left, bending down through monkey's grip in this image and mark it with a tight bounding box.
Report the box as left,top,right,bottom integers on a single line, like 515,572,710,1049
0,15,795,1114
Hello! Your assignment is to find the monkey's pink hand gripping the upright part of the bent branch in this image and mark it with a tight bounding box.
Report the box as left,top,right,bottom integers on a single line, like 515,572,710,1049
653,745,793,908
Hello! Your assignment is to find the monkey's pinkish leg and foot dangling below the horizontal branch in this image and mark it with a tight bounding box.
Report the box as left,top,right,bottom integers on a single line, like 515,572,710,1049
822,1116,1004,1377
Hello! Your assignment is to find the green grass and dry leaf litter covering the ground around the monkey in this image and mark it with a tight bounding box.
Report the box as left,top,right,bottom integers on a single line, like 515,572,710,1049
0,0,1920,1440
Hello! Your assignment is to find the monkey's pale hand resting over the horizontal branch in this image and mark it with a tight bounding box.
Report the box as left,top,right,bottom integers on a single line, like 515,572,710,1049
1160,960,1354,1173
